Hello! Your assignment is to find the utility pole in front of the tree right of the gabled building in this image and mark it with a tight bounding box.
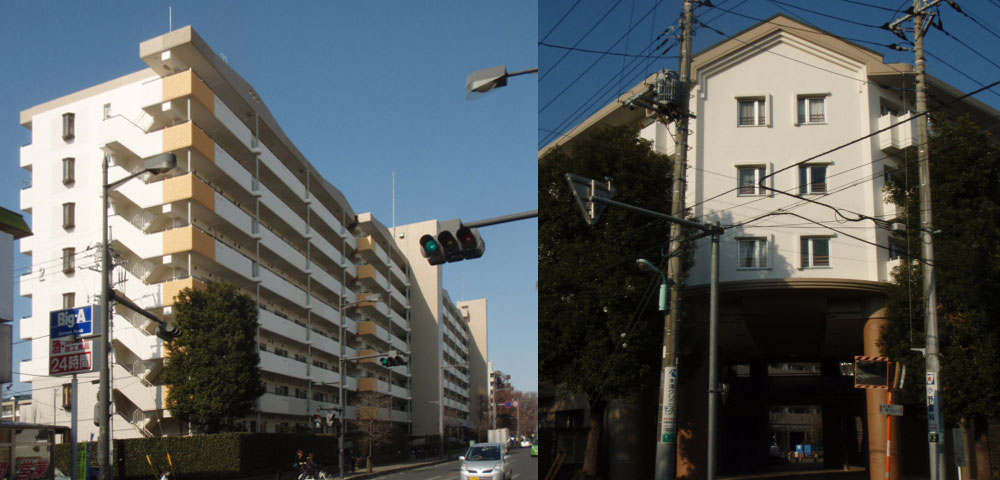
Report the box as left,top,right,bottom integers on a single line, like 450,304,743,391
889,0,946,480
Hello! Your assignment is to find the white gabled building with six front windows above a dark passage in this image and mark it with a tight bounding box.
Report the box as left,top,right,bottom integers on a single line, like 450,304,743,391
539,15,1000,478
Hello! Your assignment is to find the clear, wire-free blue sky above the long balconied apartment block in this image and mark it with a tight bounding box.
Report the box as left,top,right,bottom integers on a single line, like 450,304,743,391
0,0,538,394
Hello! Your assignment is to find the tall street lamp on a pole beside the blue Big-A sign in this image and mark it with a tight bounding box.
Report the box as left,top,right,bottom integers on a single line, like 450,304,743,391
97,153,177,480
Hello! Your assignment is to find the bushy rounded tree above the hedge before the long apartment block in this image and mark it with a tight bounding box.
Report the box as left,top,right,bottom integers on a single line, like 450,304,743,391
163,283,264,433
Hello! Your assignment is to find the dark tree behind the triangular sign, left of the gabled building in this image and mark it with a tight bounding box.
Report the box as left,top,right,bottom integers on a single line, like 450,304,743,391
538,126,671,476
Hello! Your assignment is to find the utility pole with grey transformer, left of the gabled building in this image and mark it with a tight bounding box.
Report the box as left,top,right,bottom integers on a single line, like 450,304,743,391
655,0,696,480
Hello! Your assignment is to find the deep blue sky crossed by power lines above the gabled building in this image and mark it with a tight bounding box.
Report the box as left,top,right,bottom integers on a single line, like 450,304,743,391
537,0,1000,148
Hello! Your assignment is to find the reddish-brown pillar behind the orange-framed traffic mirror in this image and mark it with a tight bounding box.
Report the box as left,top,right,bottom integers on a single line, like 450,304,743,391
864,308,901,480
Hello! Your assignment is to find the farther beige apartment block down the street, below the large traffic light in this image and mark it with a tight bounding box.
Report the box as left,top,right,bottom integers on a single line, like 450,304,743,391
393,220,489,438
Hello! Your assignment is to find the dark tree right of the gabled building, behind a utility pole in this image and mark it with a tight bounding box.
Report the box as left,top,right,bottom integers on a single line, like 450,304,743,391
882,115,1000,478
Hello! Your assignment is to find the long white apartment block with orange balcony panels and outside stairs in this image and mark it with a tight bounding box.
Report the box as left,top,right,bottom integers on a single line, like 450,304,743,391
19,27,412,438
